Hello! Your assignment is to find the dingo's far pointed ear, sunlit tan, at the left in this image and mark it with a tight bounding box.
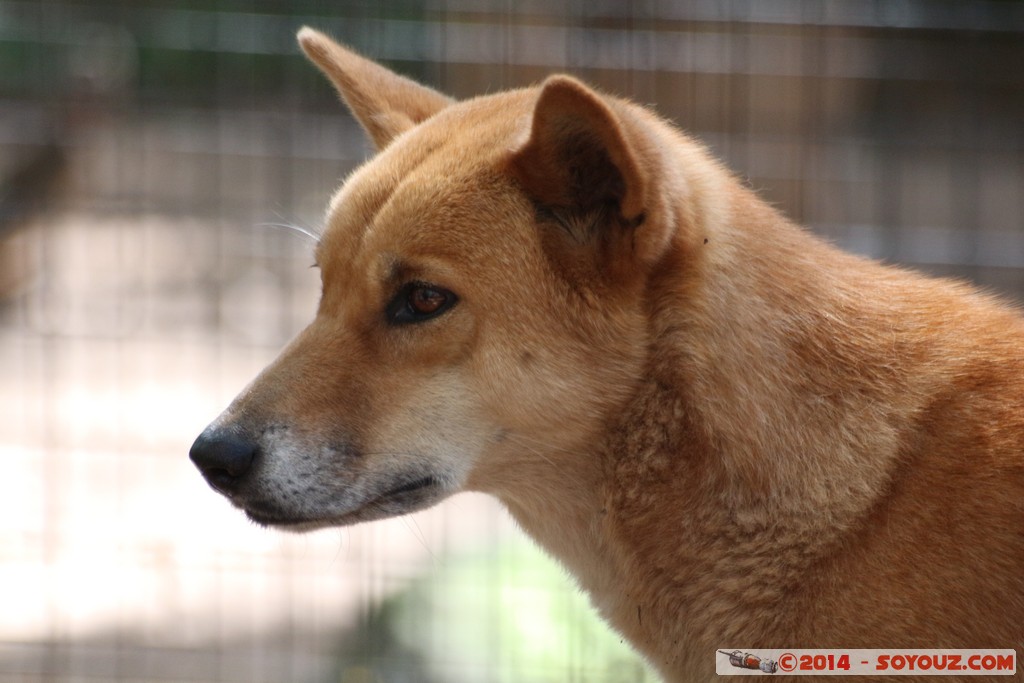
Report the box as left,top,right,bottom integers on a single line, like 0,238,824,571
298,27,453,150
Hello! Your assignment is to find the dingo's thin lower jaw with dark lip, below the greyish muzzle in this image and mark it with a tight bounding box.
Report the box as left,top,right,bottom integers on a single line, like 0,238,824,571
239,475,450,531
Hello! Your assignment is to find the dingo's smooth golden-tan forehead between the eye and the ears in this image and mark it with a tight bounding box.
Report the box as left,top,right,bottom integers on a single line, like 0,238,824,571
316,91,536,282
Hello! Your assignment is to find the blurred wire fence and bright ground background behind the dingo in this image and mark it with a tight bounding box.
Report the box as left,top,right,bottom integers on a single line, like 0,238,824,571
0,0,1024,683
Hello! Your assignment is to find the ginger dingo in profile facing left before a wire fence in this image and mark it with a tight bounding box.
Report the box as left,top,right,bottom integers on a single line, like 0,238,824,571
190,29,1024,681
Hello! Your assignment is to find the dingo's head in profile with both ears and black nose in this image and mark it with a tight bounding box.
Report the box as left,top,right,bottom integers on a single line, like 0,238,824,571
190,29,688,529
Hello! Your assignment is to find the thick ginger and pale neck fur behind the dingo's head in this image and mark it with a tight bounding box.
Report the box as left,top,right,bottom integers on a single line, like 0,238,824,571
497,148,1019,681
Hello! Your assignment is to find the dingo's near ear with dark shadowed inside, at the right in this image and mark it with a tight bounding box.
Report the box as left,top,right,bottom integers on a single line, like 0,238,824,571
512,76,647,224
